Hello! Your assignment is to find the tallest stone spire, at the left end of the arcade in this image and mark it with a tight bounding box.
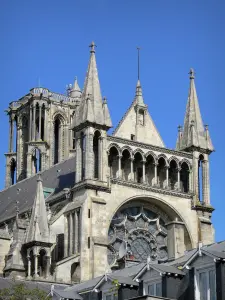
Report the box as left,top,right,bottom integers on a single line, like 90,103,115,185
72,42,112,128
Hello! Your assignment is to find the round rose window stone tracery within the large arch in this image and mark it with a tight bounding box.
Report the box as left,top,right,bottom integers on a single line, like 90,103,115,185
108,206,168,266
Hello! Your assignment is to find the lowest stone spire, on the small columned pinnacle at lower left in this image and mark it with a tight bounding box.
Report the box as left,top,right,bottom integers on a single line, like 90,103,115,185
26,176,49,243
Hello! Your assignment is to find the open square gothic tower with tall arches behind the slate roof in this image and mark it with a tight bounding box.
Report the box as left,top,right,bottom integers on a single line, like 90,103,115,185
5,79,81,187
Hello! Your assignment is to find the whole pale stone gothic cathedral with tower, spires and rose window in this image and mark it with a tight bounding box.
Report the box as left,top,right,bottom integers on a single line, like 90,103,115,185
0,42,214,283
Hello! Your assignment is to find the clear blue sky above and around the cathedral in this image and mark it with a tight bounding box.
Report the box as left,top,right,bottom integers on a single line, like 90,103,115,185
0,0,225,241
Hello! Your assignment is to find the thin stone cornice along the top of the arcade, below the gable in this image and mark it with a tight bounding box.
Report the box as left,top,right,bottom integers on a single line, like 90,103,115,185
107,135,193,159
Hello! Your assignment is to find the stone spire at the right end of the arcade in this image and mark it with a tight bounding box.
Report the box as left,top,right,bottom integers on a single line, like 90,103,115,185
177,69,214,151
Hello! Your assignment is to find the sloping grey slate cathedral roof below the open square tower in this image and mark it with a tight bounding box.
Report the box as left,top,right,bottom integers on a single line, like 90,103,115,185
0,157,75,223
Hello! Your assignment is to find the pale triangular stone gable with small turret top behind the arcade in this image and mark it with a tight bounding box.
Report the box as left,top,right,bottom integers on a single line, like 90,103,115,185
113,80,165,147
